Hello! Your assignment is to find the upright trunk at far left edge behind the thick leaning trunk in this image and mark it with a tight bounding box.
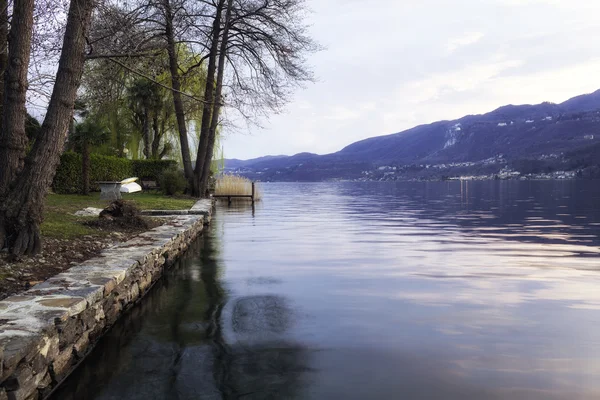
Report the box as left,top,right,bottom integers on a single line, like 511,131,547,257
0,0,34,197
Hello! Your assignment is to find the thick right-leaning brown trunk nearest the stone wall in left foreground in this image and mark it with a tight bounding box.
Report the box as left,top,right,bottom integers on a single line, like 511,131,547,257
0,0,94,255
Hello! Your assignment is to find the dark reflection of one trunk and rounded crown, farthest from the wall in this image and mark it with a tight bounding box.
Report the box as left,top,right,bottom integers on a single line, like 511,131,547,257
201,231,307,400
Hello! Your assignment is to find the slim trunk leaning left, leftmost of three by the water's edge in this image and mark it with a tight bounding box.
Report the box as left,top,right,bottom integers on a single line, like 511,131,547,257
162,0,194,178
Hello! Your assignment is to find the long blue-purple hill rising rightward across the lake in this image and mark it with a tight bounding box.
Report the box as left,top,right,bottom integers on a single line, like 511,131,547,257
225,90,600,181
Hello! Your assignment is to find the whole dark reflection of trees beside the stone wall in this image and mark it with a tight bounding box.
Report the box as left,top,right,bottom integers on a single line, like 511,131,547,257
53,231,307,400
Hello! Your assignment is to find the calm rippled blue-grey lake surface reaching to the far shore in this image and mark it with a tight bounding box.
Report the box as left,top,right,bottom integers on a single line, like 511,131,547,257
54,181,600,400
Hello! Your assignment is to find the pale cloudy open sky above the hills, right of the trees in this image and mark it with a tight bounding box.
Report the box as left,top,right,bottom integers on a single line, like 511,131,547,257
223,0,600,159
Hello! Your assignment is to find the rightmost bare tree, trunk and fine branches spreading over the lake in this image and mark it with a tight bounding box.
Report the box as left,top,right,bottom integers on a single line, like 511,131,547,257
195,0,318,195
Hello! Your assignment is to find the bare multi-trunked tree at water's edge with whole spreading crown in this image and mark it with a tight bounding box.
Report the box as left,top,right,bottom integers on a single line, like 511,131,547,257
79,0,318,196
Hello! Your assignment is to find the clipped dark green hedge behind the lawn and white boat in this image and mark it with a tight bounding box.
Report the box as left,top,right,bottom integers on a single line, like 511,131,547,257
52,152,177,194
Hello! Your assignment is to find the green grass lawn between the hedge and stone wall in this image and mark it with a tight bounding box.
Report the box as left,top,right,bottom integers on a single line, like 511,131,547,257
40,193,195,239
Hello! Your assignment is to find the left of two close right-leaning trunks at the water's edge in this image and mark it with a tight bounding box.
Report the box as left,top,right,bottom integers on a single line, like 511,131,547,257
192,0,225,197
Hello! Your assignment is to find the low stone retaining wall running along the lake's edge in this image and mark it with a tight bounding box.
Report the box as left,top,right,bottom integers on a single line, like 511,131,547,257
0,205,211,400
